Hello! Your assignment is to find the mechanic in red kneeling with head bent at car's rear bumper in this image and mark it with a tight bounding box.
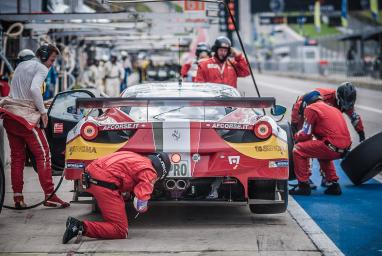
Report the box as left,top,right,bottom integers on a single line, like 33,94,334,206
62,151,171,244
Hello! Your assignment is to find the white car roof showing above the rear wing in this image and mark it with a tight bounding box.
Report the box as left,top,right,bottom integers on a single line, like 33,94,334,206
122,82,240,98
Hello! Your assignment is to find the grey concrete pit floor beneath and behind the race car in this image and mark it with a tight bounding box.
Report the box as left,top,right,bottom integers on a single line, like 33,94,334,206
0,167,321,256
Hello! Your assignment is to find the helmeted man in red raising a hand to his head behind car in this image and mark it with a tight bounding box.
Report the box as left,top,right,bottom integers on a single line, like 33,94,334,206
195,36,250,88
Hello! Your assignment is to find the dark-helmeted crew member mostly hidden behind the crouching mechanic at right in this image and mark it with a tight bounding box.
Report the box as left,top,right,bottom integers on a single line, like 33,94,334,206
291,82,365,142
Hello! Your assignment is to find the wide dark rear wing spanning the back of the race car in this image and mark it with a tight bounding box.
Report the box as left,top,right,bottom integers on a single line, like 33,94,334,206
76,97,276,108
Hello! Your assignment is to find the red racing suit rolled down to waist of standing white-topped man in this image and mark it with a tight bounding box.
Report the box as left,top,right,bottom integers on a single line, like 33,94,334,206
0,97,54,196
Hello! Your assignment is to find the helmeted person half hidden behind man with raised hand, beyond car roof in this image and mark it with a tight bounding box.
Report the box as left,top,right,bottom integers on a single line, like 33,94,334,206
180,42,211,82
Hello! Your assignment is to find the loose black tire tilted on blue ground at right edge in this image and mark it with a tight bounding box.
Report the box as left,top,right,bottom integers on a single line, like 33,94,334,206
341,132,382,185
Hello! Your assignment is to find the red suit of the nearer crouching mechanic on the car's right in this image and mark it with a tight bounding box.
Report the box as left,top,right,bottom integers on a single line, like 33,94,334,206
293,101,351,182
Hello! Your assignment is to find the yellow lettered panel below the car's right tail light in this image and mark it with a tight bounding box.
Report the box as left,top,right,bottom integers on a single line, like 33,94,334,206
227,135,288,159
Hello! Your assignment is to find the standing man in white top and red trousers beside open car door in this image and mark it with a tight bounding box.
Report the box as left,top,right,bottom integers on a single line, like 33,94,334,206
0,44,70,208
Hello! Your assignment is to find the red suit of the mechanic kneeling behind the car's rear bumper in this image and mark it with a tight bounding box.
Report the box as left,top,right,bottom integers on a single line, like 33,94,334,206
84,151,157,239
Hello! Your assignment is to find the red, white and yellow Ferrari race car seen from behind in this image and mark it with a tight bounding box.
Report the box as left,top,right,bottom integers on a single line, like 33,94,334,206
49,83,289,213
